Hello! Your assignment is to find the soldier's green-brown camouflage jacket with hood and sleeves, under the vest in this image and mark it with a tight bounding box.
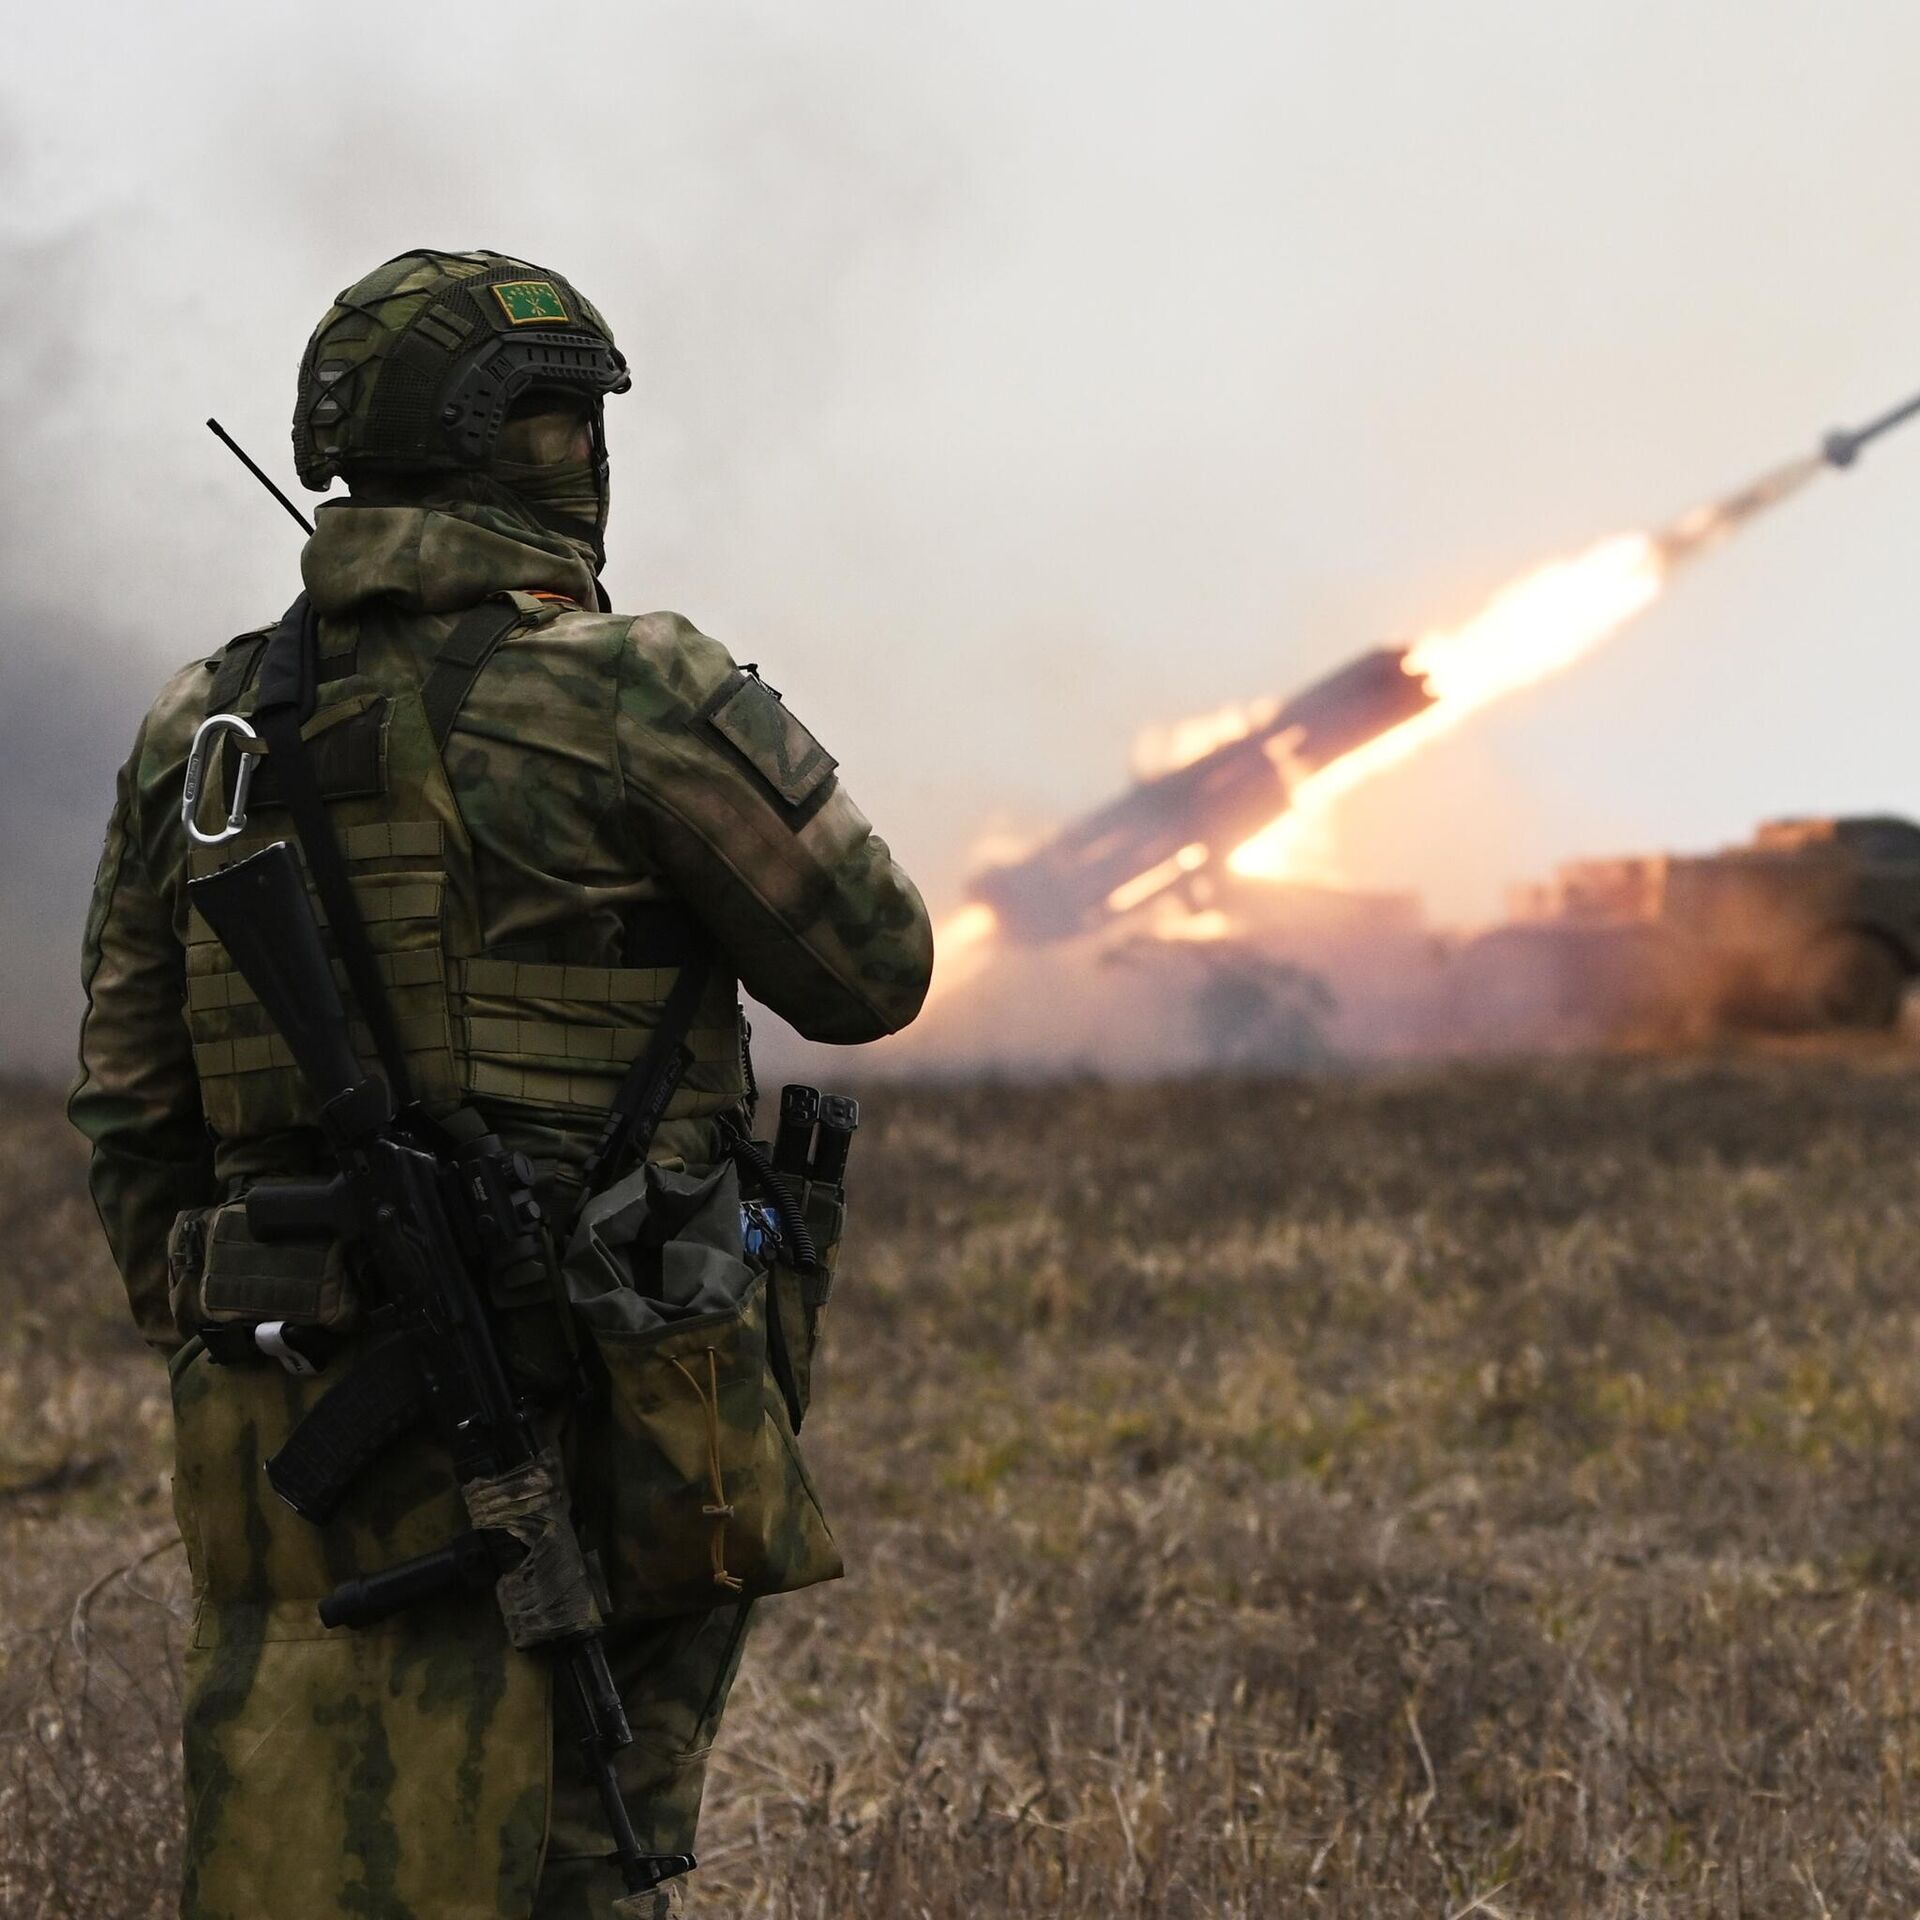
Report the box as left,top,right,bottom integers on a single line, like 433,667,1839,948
71,501,933,1348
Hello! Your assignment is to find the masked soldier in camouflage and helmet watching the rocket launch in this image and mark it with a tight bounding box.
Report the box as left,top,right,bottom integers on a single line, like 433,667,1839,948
71,250,933,1920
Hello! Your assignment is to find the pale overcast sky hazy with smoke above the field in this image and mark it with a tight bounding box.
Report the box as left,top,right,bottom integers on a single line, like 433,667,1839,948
0,0,1920,1066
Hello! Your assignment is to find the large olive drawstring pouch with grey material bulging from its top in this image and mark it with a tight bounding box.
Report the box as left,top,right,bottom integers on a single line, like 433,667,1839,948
563,1162,843,1620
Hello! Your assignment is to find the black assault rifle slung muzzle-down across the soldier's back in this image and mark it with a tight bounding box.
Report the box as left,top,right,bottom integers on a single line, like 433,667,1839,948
188,841,695,1905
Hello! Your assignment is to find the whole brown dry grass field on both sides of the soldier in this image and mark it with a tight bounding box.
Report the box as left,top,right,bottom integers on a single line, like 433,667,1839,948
11,1058,1920,1920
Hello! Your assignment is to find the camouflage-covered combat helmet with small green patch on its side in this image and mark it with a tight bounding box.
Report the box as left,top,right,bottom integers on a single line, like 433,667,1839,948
294,248,634,493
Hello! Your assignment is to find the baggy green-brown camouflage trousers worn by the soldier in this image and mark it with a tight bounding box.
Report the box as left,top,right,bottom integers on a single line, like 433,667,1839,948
171,1342,751,1920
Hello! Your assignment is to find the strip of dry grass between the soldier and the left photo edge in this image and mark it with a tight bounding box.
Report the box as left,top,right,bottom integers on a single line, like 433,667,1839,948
0,1083,184,1920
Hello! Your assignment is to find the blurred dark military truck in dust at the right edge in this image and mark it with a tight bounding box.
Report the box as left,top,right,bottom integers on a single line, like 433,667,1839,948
1455,814,1920,1037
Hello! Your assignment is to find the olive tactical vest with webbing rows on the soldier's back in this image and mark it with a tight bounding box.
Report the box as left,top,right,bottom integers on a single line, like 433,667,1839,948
186,593,749,1146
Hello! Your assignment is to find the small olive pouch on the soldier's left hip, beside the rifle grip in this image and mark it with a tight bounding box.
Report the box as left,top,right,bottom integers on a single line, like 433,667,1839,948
167,1200,359,1338
